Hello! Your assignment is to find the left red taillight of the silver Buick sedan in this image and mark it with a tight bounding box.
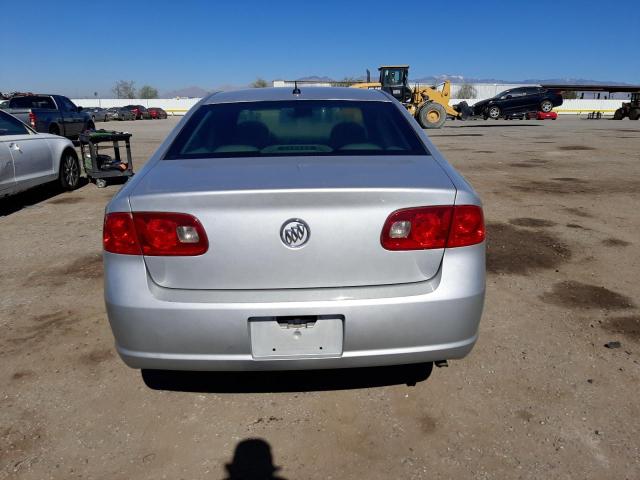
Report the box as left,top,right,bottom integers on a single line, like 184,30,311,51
103,212,209,256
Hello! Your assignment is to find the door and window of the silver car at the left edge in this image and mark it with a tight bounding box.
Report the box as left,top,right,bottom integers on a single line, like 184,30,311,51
0,112,54,189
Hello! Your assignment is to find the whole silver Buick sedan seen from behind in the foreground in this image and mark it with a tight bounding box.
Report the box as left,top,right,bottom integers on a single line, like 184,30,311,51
103,88,485,370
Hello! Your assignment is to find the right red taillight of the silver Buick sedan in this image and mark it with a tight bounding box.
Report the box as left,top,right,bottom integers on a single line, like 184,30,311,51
380,205,484,250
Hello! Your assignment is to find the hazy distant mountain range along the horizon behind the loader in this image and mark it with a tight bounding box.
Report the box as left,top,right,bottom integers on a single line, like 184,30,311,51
161,72,629,98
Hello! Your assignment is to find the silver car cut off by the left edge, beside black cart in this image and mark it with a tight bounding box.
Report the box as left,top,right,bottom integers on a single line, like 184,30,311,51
0,110,80,197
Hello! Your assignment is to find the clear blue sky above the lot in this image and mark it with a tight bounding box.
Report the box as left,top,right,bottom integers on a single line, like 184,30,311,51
0,0,640,98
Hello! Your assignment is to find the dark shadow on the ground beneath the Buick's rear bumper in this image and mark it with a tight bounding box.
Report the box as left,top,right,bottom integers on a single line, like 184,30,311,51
142,363,433,393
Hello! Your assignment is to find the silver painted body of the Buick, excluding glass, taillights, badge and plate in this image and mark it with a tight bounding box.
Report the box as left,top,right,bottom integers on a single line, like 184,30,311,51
104,88,485,370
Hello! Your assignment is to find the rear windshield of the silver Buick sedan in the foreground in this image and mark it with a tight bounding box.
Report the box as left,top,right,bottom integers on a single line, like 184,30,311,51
165,100,427,160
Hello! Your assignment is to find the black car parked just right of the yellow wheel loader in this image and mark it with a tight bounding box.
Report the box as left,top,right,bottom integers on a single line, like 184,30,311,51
473,87,562,120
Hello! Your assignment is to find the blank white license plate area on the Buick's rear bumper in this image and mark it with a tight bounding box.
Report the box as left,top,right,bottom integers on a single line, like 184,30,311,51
249,315,344,358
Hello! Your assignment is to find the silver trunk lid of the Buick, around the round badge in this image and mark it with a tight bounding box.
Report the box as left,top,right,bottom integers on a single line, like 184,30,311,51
130,155,456,290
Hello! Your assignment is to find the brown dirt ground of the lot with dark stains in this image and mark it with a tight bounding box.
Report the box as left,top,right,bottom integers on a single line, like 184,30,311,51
0,118,640,480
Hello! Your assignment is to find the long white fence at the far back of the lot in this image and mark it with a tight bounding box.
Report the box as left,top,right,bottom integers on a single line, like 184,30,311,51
73,98,624,115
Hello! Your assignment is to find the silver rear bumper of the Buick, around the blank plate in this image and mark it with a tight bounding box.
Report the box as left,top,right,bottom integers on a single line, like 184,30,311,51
104,244,485,371
